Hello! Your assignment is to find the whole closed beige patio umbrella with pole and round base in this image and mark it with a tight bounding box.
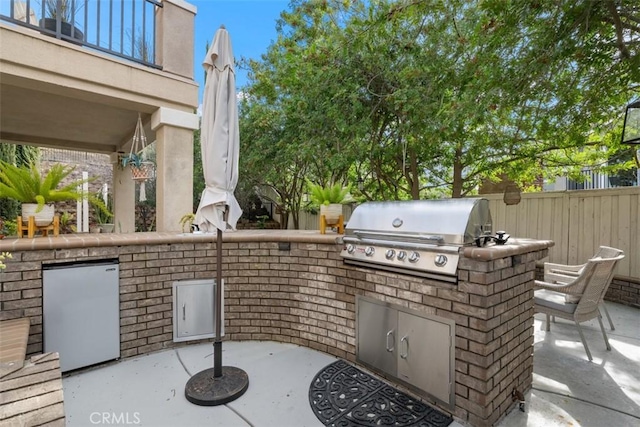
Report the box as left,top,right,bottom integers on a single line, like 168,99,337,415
185,26,249,406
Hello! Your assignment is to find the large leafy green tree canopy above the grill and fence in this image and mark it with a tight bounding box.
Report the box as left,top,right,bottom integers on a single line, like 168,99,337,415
240,0,640,202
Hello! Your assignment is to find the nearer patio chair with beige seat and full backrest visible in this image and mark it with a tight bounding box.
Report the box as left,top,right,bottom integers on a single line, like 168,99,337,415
534,254,624,361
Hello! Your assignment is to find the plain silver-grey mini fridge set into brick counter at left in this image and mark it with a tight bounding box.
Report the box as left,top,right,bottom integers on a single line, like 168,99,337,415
42,260,120,372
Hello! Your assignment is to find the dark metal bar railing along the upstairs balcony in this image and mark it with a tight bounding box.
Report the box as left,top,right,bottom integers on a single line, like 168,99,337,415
0,0,162,69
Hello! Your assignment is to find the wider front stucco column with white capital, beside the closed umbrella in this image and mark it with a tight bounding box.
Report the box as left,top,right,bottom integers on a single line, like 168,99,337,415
151,108,198,231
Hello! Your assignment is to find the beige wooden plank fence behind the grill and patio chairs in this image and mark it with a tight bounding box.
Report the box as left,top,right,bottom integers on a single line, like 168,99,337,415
290,187,640,280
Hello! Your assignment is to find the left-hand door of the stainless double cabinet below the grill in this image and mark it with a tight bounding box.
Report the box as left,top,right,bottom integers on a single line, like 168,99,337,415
356,299,398,376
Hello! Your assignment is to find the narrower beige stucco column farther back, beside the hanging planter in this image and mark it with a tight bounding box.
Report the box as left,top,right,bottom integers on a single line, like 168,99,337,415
111,154,136,233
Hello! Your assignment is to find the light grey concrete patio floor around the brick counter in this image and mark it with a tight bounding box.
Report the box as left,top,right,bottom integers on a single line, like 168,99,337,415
63,303,640,427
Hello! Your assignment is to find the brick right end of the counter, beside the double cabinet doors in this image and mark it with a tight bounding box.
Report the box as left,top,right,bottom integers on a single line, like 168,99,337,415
456,249,548,426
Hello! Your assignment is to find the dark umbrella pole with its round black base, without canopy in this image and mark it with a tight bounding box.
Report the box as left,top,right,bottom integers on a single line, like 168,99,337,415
184,206,249,406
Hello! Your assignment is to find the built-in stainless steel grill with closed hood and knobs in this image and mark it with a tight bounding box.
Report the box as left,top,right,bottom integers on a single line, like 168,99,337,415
341,198,492,282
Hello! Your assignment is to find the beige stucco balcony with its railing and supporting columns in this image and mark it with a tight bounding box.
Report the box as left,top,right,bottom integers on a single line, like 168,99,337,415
0,0,198,232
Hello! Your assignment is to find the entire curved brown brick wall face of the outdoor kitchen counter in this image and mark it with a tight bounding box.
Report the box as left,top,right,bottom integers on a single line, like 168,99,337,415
0,242,547,426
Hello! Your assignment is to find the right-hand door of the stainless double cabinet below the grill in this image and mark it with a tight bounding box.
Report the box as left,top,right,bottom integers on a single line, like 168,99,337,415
398,312,452,402
